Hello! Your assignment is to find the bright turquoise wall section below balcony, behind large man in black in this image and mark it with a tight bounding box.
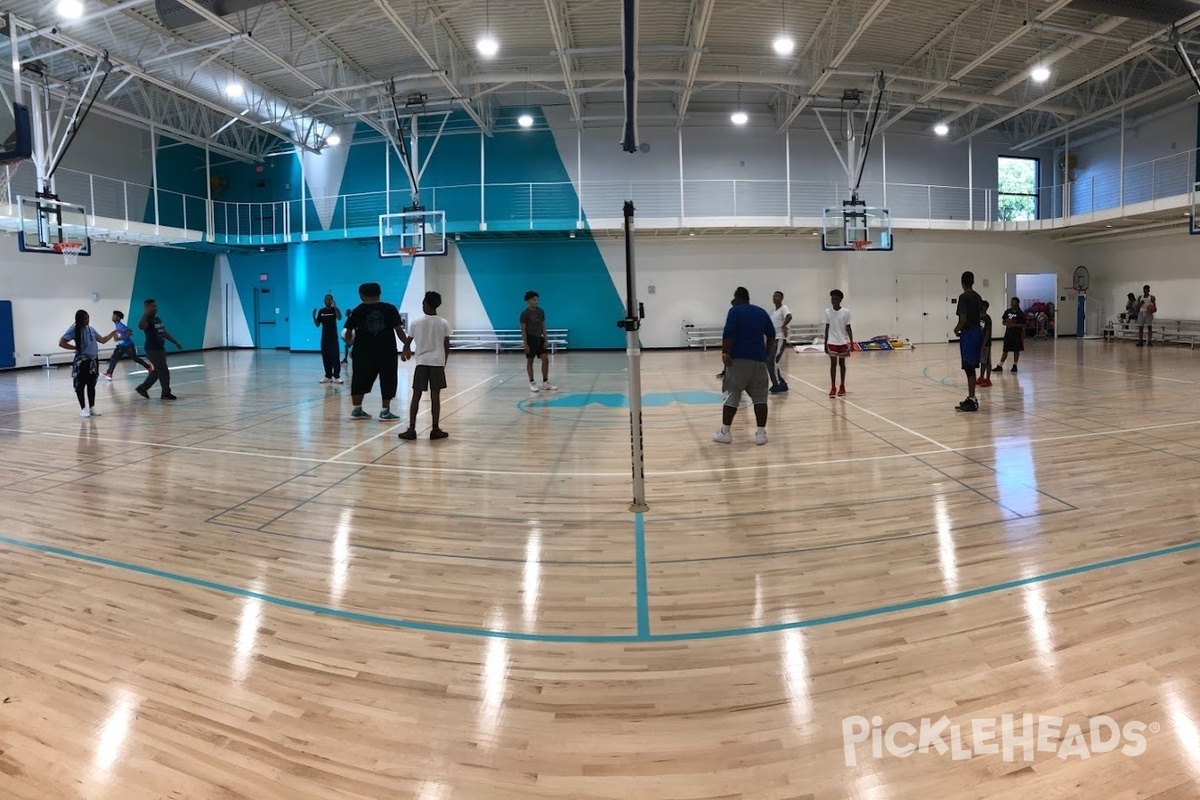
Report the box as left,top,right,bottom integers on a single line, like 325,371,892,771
287,239,412,351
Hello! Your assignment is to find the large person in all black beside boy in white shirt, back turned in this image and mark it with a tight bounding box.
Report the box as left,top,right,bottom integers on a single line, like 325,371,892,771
346,283,408,420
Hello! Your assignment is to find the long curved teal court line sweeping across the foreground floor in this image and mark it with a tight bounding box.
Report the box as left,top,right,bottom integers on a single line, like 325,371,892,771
0,536,1200,644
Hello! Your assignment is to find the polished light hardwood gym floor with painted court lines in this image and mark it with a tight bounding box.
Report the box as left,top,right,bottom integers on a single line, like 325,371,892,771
0,339,1200,800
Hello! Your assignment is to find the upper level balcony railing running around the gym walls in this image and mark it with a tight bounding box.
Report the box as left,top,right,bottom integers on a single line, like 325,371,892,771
7,144,1196,245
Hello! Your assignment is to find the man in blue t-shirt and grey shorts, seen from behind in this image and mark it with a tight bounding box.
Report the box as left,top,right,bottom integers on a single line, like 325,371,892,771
713,287,775,445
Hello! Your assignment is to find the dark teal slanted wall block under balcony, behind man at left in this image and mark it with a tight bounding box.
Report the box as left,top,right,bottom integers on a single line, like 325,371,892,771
128,247,214,350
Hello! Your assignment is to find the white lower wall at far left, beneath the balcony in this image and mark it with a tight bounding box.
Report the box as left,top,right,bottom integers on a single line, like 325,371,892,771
0,236,138,367
